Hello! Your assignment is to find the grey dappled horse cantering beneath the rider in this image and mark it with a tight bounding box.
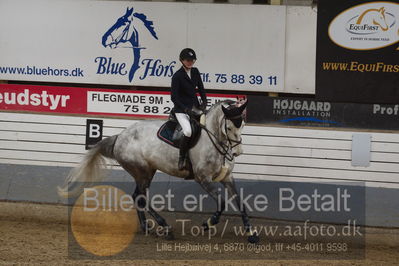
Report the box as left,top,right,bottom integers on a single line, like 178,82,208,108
59,100,259,243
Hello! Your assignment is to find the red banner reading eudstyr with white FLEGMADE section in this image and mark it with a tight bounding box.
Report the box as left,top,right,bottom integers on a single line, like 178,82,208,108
0,84,245,118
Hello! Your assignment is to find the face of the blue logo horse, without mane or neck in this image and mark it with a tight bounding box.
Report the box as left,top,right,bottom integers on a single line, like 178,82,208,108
102,8,133,49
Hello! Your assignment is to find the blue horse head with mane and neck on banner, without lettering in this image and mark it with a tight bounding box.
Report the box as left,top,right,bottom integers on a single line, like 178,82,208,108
102,8,158,82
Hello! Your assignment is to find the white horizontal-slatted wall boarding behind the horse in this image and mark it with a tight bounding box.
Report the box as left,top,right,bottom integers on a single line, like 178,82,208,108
0,112,399,187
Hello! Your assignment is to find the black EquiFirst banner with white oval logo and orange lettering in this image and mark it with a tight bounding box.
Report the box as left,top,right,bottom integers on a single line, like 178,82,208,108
316,0,399,103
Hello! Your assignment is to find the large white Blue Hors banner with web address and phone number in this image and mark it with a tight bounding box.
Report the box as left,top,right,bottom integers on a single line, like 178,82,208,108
0,0,286,92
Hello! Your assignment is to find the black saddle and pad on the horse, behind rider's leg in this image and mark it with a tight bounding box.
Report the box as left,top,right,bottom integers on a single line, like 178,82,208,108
157,109,201,149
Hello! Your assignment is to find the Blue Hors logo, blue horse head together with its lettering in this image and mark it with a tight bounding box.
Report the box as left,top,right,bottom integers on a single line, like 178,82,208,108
94,8,176,82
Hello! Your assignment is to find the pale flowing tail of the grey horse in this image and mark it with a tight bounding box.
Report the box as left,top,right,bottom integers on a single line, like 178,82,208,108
58,135,118,198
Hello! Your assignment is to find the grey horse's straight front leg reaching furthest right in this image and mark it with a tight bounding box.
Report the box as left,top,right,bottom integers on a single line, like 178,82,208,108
221,175,259,243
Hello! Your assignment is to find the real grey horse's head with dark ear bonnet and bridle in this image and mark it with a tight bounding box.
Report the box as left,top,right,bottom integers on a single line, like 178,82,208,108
220,101,247,156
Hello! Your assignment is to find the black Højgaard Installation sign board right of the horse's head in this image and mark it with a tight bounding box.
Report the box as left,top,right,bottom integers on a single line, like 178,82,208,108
247,96,399,130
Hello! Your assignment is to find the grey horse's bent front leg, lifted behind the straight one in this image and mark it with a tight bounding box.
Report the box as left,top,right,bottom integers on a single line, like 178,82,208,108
198,179,225,230
